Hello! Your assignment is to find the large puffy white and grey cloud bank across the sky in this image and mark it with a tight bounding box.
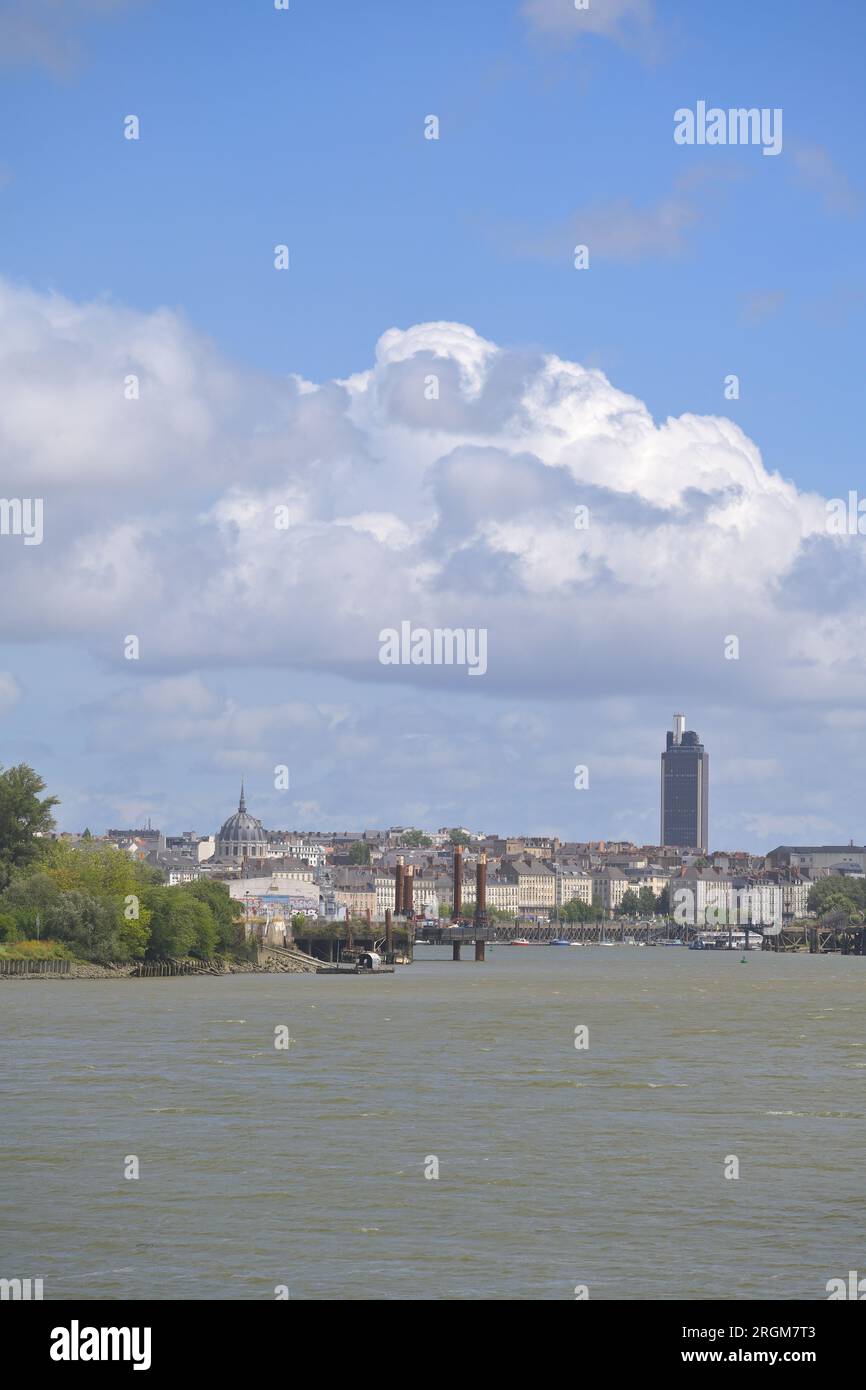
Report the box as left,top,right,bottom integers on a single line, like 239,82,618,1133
0,276,866,746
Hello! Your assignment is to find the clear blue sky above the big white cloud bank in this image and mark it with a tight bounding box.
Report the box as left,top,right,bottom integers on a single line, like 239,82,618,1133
1,0,866,489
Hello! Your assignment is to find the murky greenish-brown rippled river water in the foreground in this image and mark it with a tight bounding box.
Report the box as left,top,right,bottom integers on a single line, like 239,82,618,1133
0,945,866,1300
